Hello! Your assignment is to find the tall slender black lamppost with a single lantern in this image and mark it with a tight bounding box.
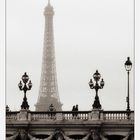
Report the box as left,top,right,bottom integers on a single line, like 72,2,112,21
124,57,132,112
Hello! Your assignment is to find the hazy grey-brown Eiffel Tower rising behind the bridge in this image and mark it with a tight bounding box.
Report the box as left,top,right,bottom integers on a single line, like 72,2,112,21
35,0,62,111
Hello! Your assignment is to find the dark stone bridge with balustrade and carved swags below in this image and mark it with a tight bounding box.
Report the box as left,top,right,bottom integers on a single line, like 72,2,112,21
6,109,134,140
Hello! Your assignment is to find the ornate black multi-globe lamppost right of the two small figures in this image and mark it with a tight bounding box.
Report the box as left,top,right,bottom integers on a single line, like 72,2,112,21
89,70,105,109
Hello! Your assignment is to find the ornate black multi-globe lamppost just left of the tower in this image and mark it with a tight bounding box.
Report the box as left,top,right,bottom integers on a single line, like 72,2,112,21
18,72,32,109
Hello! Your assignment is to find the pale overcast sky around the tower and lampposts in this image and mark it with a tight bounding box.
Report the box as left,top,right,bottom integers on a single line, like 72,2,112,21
6,0,134,110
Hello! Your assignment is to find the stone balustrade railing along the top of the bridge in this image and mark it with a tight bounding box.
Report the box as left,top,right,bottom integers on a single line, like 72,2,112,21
6,110,134,121
